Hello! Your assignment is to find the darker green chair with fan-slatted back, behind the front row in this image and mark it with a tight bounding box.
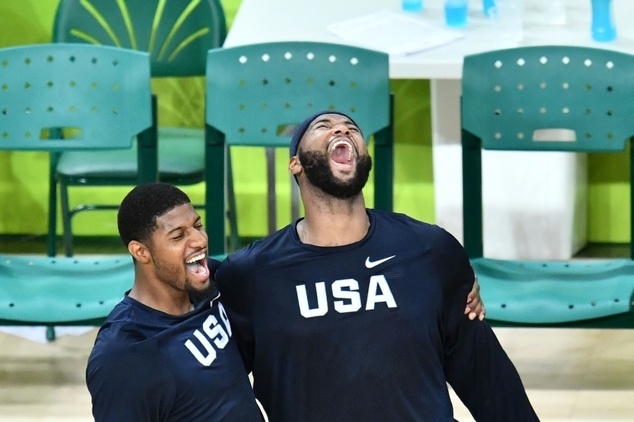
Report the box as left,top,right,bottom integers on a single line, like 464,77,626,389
49,0,226,256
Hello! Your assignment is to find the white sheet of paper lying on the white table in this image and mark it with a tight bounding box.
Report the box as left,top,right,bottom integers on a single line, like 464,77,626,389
327,10,463,55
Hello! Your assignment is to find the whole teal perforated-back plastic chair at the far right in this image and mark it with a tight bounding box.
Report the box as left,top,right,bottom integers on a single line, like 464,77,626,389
462,46,634,328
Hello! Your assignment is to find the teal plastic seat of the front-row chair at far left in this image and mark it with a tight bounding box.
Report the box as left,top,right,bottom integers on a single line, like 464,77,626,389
0,254,134,325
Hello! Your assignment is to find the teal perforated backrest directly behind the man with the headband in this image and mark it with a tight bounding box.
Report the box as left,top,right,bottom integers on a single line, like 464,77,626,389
205,42,390,146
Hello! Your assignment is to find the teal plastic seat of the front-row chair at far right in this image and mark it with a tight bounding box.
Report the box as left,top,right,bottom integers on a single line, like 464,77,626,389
471,258,634,324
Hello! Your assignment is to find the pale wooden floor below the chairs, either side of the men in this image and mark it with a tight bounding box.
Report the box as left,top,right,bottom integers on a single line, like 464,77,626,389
0,328,634,422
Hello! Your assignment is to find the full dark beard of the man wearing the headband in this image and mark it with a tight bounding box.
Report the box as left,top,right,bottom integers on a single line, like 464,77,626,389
298,149,372,199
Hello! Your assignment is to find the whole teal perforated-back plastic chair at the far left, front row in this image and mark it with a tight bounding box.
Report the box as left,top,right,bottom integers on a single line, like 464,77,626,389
0,44,157,339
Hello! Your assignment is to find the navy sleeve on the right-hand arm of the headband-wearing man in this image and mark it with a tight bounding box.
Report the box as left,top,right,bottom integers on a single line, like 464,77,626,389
434,229,539,422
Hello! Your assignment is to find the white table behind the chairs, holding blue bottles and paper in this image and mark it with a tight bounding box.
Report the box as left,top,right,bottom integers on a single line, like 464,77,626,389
225,0,634,258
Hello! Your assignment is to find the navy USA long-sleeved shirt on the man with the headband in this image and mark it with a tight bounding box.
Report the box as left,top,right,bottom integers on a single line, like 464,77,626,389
216,210,538,422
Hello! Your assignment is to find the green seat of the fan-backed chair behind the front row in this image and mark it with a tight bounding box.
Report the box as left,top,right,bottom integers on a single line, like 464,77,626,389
57,128,205,180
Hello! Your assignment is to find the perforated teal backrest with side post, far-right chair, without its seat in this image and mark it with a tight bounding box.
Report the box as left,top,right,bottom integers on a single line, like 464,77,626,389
461,46,634,259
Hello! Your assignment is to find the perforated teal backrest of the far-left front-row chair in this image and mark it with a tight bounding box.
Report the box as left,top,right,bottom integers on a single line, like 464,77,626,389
0,44,153,156
